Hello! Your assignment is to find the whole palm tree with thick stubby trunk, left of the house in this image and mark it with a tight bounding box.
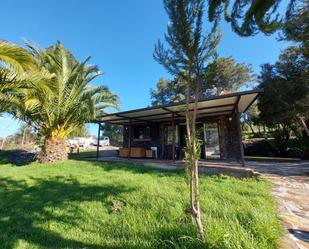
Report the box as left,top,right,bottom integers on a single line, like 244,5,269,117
12,42,118,163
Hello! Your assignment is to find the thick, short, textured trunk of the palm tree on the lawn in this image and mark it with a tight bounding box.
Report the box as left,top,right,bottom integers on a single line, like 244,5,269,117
38,137,68,163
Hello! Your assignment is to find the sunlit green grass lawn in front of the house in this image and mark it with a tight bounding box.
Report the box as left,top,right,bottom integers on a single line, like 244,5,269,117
0,154,281,249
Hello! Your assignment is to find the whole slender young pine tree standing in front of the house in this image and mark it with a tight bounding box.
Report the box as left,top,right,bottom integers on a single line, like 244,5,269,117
154,0,220,240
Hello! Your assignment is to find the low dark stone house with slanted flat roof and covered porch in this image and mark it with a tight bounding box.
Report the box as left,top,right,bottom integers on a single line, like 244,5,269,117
96,90,261,162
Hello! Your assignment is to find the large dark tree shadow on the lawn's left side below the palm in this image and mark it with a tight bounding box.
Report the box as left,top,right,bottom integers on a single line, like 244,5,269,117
0,177,134,249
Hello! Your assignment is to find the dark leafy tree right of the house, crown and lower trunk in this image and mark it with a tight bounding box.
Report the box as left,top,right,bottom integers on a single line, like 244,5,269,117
257,43,309,155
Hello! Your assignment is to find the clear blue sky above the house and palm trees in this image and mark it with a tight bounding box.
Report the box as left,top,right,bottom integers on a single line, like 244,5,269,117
0,0,288,137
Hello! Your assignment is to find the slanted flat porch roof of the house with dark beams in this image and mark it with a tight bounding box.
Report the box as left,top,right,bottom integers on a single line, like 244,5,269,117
95,90,262,125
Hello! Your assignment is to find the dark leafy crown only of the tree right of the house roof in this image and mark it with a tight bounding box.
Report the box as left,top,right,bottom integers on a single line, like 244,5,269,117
258,44,309,125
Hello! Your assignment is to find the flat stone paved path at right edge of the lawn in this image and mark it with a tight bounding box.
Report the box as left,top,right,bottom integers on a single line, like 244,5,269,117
247,161,309,249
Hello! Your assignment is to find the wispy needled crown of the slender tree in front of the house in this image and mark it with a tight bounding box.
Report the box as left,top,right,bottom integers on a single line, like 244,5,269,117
154,0,221,83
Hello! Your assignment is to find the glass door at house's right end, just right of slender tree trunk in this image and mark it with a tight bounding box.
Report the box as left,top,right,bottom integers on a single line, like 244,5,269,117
204,123,220,159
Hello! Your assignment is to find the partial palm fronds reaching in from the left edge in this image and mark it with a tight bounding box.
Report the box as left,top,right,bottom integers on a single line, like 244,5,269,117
0,40,36,113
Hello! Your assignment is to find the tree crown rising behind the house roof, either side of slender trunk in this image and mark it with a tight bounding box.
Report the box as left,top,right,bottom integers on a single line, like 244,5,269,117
150,57,256,105
